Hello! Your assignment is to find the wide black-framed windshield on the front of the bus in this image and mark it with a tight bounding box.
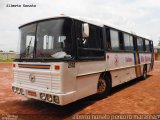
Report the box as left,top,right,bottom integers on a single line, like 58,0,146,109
20,18,73,59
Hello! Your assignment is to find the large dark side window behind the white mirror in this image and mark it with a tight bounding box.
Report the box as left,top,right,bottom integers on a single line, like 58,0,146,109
76,23,105,59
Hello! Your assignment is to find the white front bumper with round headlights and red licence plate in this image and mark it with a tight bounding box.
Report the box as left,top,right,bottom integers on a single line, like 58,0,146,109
12,85,76,106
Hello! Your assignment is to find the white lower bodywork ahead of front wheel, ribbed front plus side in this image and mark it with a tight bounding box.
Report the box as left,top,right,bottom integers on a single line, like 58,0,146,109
12,61,105,105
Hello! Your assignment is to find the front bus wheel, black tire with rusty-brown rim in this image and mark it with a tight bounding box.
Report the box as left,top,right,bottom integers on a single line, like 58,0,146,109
97,75,111,98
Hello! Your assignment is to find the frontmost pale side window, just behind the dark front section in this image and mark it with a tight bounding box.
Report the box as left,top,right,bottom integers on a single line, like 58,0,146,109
110,30,120,51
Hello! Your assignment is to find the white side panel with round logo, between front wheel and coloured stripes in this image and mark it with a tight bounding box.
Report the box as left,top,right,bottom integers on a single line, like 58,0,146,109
106,52,136,87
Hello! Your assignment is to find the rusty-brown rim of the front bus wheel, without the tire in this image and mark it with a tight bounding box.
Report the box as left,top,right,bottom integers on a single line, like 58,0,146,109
98,79,106,94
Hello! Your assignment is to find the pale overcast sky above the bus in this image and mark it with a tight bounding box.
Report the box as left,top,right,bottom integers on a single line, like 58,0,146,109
0,0,160,51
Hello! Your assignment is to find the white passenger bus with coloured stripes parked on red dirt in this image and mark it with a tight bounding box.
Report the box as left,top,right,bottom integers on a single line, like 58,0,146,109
12,15,154,106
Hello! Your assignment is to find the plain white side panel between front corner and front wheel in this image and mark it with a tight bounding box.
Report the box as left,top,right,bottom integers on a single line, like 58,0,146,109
76,61,106,99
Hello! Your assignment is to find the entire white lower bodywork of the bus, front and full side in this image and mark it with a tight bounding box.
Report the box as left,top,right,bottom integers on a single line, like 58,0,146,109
13,52,151,105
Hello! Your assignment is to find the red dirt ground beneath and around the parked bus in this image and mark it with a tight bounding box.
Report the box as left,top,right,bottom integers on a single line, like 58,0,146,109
0,62,160,120
